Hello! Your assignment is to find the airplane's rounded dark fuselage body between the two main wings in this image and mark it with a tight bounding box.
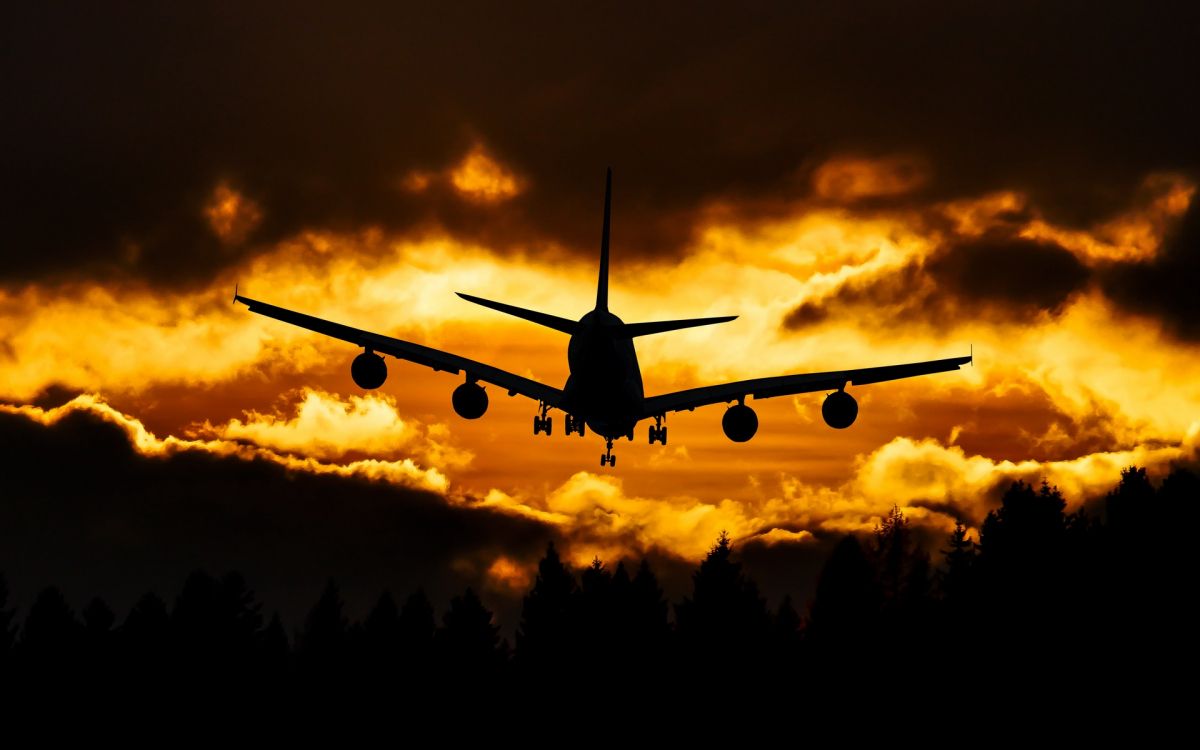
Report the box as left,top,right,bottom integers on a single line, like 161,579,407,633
563,310,646,439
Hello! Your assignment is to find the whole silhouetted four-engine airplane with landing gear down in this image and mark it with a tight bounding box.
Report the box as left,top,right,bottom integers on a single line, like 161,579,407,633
234,168,974,467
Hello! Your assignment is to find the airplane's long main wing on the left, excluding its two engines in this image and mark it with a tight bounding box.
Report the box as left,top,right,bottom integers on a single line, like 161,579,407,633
241,294,563,407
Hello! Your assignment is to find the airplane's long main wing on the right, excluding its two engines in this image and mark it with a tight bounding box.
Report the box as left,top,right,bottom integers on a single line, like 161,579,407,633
642,356,972,416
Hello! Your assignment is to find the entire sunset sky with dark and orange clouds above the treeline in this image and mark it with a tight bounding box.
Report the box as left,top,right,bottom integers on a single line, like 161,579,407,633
0,2,1200,619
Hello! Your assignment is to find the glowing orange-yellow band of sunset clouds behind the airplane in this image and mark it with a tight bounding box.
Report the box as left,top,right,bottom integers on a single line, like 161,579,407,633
0,168,1200,566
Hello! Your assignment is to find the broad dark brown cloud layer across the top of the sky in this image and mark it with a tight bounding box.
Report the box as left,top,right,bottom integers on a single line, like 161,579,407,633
0,2,1200,283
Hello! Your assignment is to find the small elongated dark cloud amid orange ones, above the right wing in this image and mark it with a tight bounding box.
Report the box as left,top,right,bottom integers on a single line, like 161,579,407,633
782,234,1092,330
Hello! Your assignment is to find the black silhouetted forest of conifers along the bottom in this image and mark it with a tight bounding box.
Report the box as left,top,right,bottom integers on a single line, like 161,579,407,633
0,468,1200,700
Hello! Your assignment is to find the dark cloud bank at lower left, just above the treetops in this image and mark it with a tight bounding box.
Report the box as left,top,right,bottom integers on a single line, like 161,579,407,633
0,403,552,624
